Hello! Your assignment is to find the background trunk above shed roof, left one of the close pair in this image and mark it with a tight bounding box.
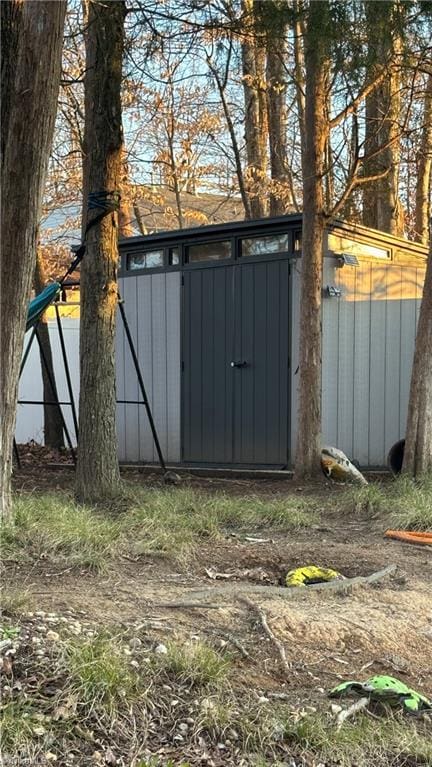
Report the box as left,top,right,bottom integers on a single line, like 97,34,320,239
241,0,268,218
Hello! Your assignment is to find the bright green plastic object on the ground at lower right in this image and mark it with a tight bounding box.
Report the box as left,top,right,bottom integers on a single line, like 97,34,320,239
329,675,432,714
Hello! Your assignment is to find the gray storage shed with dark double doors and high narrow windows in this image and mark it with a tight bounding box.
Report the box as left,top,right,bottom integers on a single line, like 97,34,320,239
117,215,427,469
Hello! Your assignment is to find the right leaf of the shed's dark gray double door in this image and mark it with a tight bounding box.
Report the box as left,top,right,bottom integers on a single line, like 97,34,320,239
234,261,288,465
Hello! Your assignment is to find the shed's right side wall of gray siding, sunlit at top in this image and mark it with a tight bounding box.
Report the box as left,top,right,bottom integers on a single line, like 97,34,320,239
322,261,424,467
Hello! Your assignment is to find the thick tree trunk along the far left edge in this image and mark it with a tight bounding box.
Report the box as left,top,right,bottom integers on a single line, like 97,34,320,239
0,0,66,518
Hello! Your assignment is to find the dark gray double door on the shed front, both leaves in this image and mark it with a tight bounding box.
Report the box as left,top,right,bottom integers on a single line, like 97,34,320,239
182,260,289,467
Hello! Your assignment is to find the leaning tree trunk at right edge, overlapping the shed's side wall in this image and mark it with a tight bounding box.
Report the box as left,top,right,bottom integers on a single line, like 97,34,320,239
403,228,432,477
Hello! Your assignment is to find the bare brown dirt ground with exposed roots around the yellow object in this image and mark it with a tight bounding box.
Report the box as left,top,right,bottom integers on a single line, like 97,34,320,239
6,468,432,706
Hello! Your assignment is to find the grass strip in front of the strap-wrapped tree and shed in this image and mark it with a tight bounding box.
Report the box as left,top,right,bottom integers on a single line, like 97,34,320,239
1,488,316,571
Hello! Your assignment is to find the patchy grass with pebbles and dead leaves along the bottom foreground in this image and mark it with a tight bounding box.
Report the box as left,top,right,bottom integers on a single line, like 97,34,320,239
1,612,432,767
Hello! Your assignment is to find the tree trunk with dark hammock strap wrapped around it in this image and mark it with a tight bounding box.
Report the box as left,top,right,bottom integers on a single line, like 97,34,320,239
75,0,125,502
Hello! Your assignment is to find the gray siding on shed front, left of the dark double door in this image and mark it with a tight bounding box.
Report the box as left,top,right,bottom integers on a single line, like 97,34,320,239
116,272,181,463
